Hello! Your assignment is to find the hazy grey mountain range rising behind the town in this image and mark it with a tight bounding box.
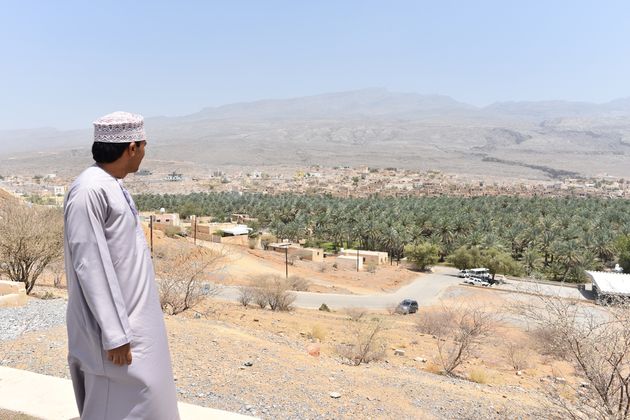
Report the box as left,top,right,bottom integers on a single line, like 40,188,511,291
0,89,630,179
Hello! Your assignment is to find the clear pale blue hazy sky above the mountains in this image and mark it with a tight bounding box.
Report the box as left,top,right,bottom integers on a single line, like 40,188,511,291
0,0,630,129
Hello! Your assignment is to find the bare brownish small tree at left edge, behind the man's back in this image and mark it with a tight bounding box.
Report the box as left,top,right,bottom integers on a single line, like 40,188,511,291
0,201,63,293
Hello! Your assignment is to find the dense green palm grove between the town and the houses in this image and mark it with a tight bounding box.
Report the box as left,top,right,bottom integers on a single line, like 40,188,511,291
136,193,630,282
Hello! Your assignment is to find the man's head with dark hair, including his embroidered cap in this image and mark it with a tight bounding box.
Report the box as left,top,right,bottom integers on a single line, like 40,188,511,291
92,112,146,176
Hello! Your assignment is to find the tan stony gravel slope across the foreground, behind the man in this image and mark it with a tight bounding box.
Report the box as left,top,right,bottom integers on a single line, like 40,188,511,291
0,289,570,419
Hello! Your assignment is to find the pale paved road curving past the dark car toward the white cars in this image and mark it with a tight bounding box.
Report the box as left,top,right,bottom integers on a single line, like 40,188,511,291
217,267,462,309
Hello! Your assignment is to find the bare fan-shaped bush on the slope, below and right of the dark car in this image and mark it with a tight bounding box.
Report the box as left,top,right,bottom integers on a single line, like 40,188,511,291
424,306,496,375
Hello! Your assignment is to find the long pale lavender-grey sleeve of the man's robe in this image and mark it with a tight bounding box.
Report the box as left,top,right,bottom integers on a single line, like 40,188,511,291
65,189,132,350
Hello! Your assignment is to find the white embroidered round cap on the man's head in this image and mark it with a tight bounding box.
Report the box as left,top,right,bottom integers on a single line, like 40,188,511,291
94,111,147,143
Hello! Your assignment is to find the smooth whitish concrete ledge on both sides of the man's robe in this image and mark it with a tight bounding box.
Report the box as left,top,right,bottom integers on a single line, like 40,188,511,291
0,366,253,420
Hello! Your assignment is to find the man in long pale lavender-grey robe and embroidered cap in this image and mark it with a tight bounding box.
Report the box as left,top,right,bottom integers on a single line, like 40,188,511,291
64,112,179,420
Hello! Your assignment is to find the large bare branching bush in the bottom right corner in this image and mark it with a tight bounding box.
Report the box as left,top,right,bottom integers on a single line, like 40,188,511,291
518,294,630,420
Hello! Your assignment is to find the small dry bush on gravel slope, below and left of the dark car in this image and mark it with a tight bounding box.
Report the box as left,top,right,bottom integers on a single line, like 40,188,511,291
337,318,387,366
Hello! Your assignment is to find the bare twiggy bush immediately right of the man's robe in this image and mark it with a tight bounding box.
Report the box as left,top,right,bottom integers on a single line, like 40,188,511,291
154,243,226,315
